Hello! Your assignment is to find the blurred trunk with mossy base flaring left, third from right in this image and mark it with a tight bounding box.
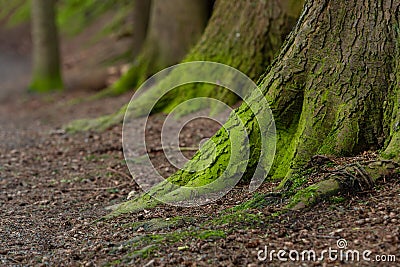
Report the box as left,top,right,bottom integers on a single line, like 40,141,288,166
102,0,211,95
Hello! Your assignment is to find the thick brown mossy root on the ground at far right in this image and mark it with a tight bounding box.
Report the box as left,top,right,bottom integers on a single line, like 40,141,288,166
285,160,398,210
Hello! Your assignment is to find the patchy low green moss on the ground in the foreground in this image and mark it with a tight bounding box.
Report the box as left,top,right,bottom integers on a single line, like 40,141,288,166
103,210,267,266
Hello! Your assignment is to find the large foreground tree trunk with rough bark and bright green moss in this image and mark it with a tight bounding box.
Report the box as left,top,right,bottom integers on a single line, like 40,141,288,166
114,0,400,218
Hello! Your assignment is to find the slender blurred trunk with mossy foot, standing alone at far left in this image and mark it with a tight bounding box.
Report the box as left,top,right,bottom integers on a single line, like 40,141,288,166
30,0,63,92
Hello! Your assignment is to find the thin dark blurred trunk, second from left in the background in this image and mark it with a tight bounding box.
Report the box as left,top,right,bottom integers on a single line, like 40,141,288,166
132,0,151,58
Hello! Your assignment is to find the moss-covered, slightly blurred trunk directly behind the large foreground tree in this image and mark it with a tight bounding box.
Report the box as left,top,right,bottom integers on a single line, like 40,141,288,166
125,0,303,113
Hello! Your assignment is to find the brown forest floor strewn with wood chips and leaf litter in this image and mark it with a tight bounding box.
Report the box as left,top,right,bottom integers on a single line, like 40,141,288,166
0,23,400,266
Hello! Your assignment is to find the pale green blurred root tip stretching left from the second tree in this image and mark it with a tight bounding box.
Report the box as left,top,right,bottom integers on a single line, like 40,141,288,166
63,105,127,133
